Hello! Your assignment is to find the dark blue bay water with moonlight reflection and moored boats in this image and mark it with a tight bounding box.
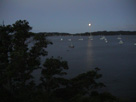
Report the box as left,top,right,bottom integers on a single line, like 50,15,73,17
44,35,136,102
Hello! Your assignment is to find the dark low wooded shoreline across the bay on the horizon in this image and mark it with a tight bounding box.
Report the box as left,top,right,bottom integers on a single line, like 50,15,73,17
35,31,136,36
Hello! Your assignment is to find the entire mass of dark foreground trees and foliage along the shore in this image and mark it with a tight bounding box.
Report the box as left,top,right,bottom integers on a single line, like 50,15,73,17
0,20,116,102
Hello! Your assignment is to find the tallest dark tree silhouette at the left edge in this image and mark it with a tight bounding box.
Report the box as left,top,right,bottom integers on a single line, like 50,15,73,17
0,20,50,100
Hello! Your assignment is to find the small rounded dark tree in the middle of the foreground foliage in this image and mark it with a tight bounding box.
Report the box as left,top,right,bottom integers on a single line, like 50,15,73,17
41,57,68,100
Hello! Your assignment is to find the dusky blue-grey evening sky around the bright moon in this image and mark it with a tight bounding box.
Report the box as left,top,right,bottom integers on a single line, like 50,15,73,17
0,0,136,33
